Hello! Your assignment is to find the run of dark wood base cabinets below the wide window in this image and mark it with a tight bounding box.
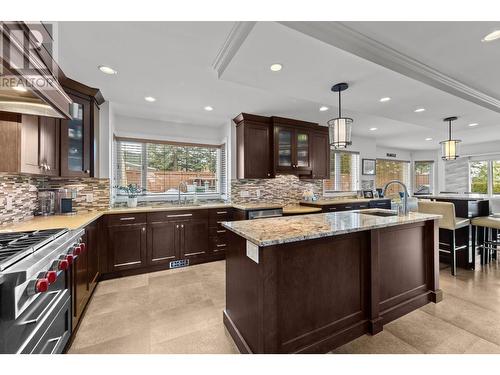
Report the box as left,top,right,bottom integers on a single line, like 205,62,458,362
100,208,232,278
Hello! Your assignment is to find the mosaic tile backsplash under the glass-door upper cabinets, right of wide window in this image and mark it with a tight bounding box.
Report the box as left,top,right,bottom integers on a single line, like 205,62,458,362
231,175,323,205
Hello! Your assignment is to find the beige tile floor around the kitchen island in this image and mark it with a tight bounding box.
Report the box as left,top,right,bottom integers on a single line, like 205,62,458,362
69,261,500,354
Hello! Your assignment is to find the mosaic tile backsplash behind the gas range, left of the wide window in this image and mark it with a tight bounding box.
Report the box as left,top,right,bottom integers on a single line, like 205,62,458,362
0,174,109,225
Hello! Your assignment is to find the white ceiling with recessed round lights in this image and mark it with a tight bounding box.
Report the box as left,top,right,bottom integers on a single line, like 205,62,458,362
58,22,500,149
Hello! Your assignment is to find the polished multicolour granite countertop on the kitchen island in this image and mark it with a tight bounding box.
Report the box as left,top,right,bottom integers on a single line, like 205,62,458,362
222,209,441,246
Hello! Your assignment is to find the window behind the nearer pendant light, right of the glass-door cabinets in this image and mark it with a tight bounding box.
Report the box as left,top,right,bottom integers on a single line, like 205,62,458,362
323,150,359,195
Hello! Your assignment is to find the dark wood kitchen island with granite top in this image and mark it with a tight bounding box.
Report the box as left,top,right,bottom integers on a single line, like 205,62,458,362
223,210,442,353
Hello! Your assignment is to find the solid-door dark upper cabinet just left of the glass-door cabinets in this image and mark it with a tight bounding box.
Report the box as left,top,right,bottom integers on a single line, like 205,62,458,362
233,113,274,179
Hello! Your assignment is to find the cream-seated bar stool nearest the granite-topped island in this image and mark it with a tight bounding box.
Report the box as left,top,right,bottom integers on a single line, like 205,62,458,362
418,201,470,276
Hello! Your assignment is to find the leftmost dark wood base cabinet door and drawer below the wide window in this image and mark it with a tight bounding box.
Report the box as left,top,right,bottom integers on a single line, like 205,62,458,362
107,214,147,272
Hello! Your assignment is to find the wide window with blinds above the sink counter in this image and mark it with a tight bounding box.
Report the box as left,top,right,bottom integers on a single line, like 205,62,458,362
113,138,227,196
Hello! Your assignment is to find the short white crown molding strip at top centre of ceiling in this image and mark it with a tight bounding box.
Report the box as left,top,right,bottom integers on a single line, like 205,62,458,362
212,21,256,78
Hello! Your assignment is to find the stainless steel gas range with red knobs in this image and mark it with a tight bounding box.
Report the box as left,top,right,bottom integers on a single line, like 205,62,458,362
0,229,85,353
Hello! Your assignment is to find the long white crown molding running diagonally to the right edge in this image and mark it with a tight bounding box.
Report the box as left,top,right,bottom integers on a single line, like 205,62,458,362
280,21,500,113
